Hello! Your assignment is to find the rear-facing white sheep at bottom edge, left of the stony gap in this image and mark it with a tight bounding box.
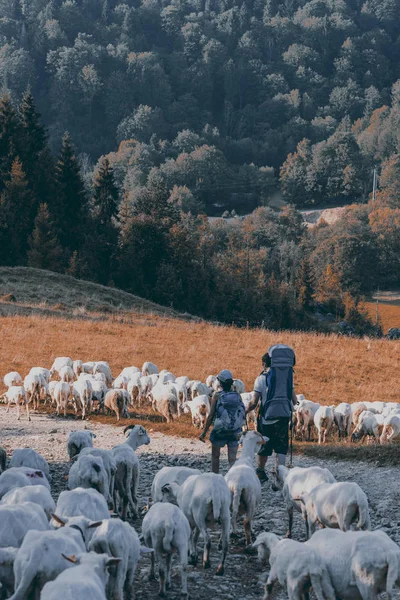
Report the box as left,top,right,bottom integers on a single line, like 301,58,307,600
89,519,145,600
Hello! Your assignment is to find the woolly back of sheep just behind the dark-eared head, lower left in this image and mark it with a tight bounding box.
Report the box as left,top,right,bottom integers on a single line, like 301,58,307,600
53,488,110,525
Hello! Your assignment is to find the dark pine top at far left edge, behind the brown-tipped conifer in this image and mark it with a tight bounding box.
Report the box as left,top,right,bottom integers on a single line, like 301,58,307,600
0,94,21,191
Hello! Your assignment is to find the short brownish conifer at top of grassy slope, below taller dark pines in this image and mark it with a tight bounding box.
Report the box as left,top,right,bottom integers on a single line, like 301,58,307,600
28,204,63,271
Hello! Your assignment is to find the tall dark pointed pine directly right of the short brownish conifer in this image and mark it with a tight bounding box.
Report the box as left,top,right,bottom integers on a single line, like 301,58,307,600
53,133,88,254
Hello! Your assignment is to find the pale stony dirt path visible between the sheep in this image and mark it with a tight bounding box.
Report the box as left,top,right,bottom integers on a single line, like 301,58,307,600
0,407,400,600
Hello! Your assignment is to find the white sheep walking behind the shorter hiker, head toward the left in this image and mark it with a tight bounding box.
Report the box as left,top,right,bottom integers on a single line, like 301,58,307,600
162,473,231,575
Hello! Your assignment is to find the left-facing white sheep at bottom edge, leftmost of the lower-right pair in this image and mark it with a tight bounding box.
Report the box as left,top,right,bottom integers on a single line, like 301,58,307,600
253,533,336,600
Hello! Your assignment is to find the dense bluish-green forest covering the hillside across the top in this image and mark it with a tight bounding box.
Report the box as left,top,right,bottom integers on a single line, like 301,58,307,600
0,0,400,214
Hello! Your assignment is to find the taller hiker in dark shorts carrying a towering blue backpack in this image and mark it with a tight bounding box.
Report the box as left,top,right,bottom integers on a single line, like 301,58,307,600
246,344,297,482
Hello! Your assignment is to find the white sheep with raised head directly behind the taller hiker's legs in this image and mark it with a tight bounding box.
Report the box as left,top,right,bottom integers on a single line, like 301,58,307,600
225,431,267,546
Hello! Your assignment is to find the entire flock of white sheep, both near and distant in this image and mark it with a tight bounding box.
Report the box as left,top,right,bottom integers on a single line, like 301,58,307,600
0,358,400,600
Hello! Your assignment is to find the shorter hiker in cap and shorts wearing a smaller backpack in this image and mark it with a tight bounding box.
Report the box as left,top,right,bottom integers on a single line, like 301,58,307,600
200,369,246,473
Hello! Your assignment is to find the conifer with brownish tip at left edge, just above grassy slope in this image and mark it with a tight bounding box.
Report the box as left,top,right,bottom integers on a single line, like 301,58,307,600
0,157,33,265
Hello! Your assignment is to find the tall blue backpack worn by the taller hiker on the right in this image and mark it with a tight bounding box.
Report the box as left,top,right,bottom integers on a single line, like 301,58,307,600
261,344,296,419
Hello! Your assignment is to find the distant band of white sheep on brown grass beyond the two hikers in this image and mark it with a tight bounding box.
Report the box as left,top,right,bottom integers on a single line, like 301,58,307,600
1,357,400,443
